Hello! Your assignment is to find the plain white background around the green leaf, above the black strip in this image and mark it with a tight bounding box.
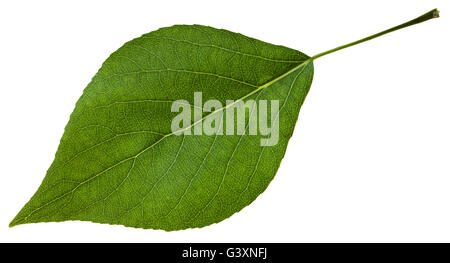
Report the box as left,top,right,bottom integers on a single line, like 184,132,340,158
0,0,450,242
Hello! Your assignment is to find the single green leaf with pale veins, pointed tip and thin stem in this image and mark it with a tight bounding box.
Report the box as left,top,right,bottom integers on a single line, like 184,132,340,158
10,8,440,230
